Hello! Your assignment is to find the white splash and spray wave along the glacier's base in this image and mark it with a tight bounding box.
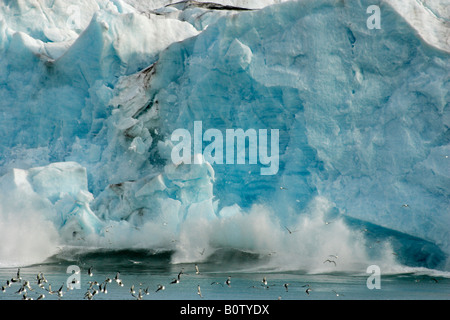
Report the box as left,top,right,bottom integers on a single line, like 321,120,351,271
0,197,446,275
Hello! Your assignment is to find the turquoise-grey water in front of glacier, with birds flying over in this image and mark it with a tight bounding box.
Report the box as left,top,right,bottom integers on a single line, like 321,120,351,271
0,250,450,301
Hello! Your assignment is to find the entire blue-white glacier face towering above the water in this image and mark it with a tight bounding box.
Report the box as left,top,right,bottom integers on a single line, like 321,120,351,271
0,0,450,272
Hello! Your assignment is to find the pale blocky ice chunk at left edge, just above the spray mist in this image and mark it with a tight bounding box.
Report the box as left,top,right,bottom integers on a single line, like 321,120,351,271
0,162,102,247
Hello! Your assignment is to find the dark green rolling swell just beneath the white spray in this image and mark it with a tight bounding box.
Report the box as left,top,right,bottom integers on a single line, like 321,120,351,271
28,246,450,281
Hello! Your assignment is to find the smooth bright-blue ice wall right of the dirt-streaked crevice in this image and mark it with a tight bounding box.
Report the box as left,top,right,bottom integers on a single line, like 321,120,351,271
134,1,450,260
